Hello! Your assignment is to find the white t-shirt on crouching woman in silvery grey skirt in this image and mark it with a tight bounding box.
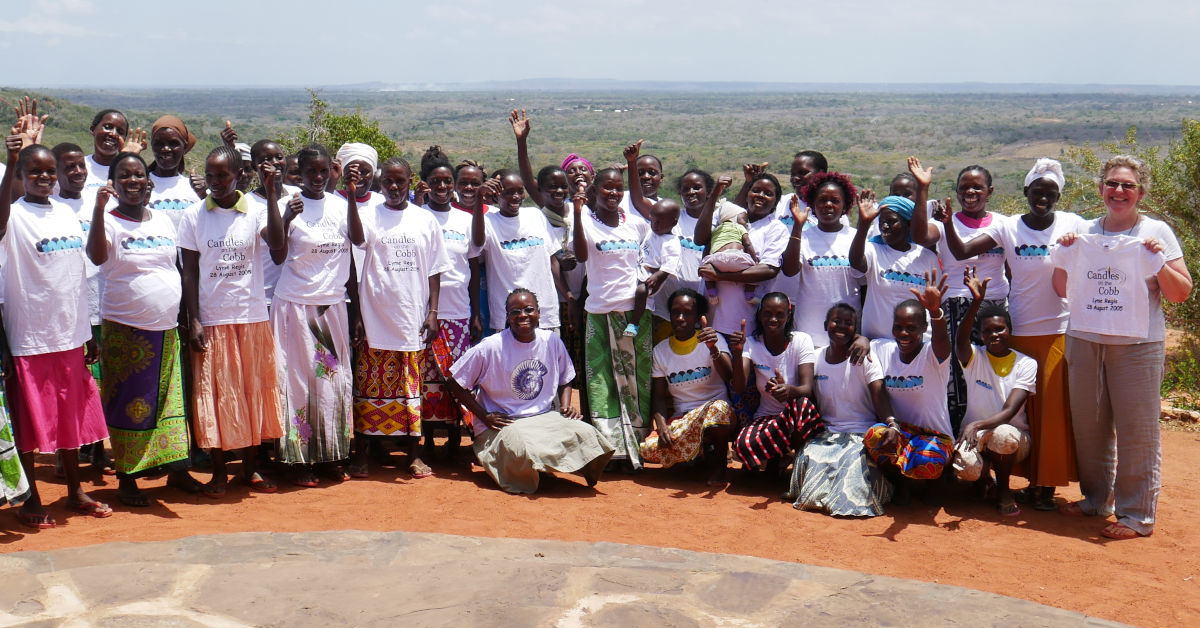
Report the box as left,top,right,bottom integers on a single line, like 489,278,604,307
814,347,883,433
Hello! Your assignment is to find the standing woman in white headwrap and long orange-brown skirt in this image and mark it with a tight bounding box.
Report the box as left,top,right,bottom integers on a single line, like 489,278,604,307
946,157,1084,510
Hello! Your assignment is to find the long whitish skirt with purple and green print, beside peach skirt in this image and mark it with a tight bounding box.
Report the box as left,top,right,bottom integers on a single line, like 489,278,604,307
271,294,354,465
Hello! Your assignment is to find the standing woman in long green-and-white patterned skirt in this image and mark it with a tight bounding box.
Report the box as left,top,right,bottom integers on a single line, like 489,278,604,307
571,168,652,471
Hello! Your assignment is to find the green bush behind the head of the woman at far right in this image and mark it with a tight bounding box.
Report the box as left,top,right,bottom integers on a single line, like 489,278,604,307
1060,119,1200,335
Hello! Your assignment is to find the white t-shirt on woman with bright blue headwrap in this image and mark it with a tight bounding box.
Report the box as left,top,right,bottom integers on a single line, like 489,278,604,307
862,240,940,340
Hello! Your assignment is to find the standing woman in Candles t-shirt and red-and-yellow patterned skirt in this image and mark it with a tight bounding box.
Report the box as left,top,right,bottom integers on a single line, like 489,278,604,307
346,157,451,478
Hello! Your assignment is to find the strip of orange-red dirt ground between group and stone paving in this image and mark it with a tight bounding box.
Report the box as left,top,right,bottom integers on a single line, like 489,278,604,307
0,430,1200,626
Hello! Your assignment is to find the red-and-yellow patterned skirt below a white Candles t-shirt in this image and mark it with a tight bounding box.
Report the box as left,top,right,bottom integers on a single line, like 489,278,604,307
354,347,425,436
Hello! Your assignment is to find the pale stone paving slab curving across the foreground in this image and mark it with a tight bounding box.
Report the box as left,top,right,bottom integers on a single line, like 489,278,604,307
0,531,1118,628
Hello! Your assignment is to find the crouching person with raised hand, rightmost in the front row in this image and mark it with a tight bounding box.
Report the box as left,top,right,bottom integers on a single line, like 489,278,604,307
953,267,1038,516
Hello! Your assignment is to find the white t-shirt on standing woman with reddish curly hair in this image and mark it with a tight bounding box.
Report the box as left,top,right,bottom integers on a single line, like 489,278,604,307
792,227,860,346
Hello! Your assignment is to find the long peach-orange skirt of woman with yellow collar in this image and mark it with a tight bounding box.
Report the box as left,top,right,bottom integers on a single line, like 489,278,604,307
190,321,283,451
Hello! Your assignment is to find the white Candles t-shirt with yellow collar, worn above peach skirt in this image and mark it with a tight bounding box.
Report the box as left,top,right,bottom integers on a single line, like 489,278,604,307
179,195,275,327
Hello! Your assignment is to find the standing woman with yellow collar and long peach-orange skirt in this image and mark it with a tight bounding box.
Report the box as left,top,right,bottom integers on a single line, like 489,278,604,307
179,145,283,497
